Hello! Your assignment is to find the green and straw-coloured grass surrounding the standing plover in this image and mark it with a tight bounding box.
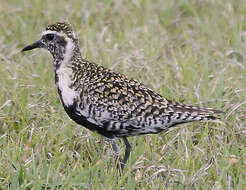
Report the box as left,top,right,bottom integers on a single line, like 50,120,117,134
0,0,246,190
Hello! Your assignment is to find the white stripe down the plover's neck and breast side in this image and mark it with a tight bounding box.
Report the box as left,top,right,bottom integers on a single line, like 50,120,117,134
55,36,77,106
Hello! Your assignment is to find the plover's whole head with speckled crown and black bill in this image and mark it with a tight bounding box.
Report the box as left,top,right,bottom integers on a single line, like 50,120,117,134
22,22,77,61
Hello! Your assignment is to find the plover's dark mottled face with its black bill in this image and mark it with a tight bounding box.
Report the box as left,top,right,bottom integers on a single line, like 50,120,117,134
22,33,67,59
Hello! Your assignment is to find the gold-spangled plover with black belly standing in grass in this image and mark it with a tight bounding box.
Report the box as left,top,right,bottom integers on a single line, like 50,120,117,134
22,22,223,170
